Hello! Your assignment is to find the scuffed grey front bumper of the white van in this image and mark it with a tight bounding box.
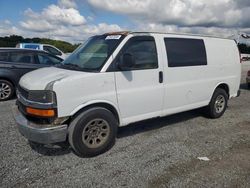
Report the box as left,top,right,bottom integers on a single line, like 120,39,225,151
13,107,68,144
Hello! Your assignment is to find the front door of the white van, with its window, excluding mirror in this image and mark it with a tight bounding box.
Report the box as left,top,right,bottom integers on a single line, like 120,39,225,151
115,36,164,124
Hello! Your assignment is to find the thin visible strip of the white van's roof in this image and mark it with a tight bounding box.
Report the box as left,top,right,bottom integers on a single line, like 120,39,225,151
105,31,234,40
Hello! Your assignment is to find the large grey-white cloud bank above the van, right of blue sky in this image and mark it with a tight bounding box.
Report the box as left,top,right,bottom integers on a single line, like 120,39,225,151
85,0,250,43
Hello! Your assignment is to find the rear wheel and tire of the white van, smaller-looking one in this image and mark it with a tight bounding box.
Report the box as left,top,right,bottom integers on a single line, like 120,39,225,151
207,88,228,119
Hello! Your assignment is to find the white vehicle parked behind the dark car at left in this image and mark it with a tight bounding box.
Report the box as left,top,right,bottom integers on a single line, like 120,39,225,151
16,43,67,59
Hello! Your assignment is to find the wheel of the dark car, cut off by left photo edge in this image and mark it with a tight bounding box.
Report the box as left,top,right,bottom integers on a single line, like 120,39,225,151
0,79,15,101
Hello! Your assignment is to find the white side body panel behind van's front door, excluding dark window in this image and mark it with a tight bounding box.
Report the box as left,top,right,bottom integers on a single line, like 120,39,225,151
158,35,241,116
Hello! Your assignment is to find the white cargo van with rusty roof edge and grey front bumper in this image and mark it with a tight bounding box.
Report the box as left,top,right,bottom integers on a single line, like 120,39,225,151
15,32,241,156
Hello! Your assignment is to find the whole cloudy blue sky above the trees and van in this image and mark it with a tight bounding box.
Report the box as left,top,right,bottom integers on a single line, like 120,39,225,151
0,0,250,43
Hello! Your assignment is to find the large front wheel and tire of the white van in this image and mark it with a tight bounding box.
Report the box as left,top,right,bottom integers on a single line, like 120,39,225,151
68,107,118,157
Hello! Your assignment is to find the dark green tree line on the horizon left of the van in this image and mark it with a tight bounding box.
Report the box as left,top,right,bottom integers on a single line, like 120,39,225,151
0,35,80,53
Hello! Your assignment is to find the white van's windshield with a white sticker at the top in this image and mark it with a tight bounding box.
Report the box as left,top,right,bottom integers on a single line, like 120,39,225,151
59,35,124,72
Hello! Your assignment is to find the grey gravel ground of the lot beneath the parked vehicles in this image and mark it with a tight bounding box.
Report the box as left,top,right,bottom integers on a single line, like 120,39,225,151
0,62,250,187
